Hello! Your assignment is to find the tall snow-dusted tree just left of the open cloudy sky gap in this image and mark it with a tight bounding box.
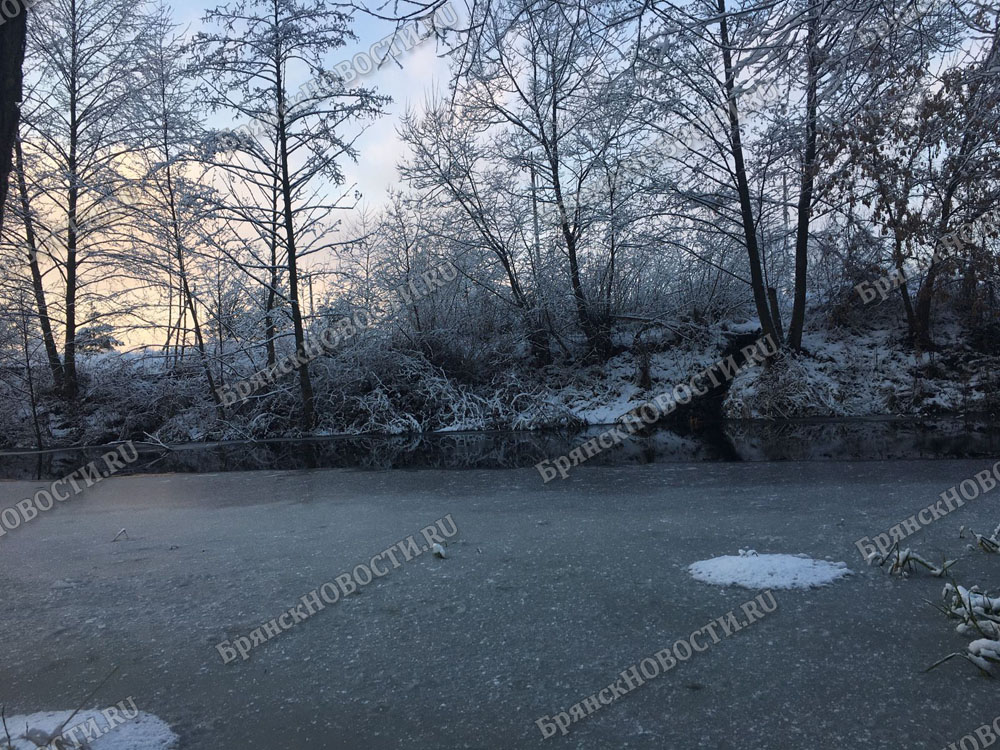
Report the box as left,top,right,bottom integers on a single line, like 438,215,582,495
194,0,386,430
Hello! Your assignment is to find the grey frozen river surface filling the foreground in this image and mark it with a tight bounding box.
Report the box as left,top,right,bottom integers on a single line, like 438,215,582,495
0,460,1000,750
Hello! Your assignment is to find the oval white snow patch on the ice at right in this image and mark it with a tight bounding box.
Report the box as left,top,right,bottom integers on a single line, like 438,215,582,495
688,550,851,589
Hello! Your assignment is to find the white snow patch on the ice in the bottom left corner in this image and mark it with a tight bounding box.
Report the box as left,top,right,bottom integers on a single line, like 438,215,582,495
0,711,177,750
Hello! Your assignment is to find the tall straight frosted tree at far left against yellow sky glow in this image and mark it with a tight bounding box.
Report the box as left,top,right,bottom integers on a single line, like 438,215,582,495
22,0,145,398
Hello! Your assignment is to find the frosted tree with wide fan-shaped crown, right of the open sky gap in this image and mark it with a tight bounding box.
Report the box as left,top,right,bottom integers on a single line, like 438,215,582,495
426,0,635,357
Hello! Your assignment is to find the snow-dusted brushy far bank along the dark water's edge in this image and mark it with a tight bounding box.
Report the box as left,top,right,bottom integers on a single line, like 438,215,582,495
19,312,1000,448
